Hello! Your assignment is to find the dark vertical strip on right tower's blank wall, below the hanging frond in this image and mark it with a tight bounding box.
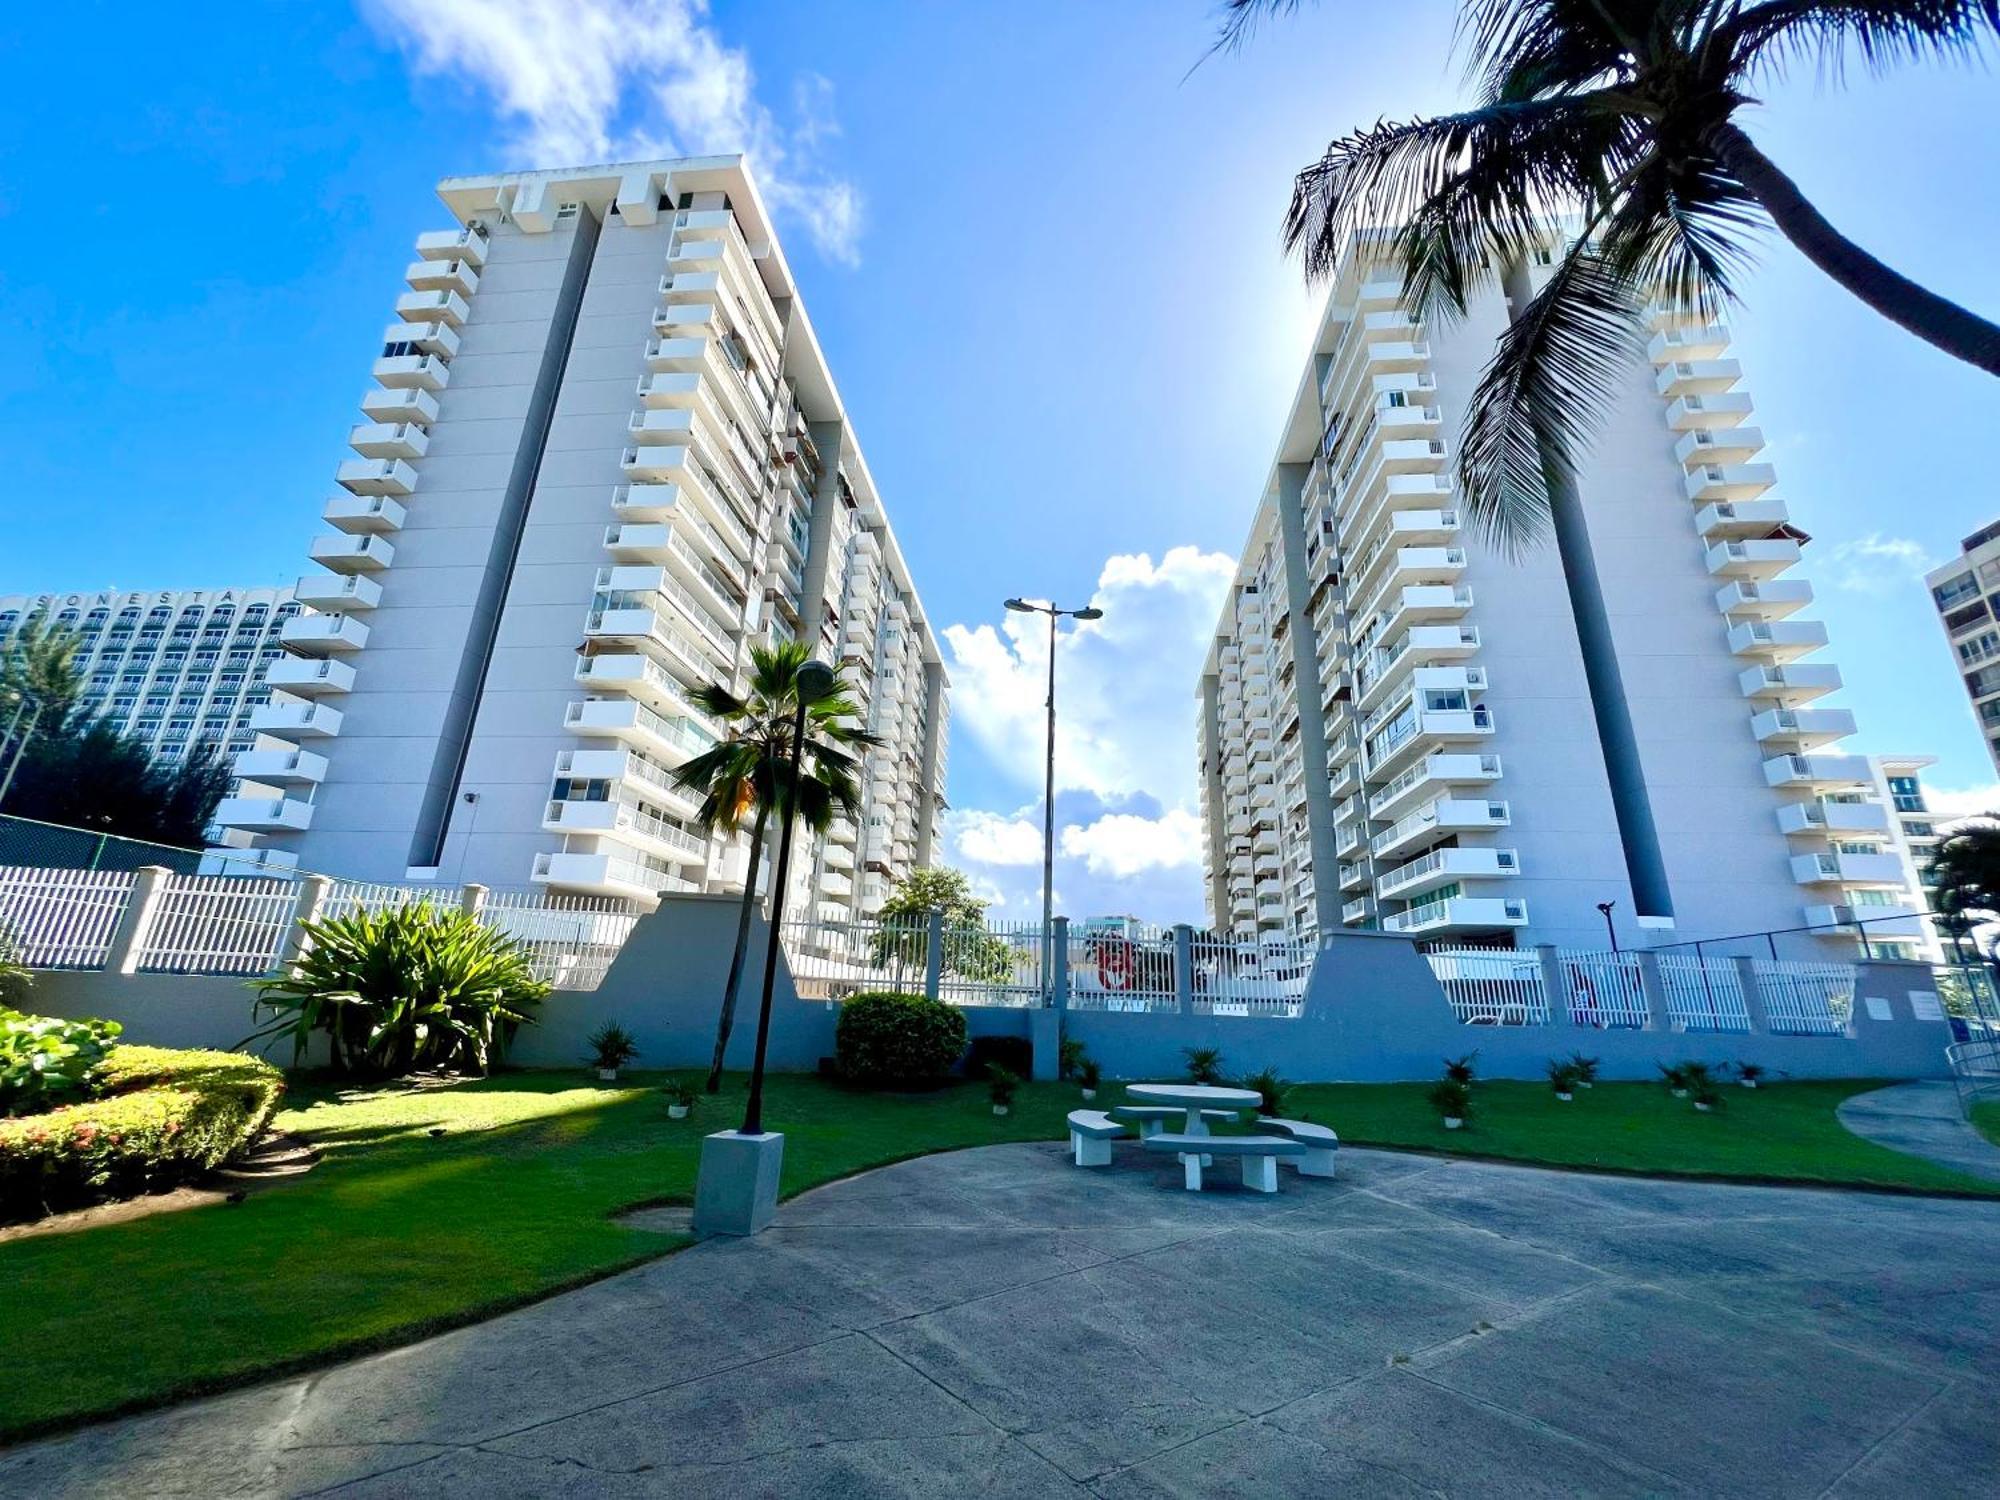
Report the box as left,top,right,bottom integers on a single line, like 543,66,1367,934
1542,460,1674,926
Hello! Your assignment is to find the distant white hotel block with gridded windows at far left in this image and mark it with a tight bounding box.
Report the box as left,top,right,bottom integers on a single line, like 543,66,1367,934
0,588,300,760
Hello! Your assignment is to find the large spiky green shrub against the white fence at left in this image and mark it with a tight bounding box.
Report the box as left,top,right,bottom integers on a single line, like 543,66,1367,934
248,902,550,1078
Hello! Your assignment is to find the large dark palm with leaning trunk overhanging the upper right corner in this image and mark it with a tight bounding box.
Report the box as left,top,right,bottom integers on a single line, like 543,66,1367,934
1220,0,2000,548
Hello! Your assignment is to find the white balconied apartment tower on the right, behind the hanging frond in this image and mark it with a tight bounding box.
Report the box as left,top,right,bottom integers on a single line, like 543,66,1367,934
1196,238,1904,954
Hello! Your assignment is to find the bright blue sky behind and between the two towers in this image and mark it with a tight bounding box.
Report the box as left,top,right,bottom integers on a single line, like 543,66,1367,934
0,0,2000,918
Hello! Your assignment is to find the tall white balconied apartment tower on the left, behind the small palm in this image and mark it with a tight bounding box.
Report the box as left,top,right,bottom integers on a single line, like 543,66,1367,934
220,156,948,920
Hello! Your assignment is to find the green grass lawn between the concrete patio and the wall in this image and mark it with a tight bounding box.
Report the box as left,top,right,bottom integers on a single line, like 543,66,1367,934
0,1072,1996,1438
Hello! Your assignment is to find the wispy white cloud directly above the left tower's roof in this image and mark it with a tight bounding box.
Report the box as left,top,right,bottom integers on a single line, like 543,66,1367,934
368,0,862,264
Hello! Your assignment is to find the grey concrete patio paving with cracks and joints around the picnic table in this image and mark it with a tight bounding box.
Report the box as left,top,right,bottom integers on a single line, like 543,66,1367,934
11,1146,2000,1500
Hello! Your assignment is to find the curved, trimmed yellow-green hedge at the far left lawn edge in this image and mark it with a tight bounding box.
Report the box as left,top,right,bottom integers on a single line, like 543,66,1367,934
0,1046,284,1220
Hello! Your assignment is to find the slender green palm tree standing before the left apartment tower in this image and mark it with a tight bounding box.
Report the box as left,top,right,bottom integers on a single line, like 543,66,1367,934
674,640,882,1094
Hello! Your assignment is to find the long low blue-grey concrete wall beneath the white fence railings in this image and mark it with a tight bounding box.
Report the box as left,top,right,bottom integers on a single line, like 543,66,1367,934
32,896,1952,1082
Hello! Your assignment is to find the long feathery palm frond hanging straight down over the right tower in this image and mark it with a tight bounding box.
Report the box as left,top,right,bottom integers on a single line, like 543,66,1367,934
1458,240,1644,556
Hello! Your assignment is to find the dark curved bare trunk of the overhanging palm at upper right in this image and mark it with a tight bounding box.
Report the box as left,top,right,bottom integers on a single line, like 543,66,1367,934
1708,122,2000,374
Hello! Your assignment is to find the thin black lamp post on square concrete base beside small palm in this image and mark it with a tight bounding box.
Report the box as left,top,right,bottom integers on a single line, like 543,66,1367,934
694,662,834,1234
